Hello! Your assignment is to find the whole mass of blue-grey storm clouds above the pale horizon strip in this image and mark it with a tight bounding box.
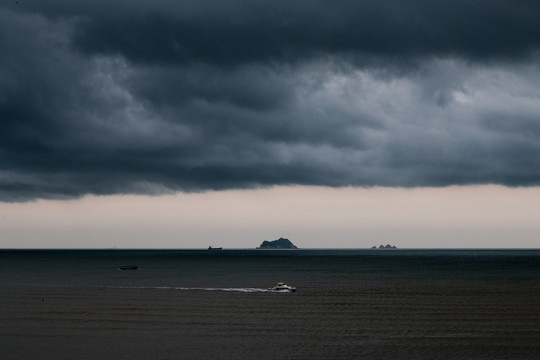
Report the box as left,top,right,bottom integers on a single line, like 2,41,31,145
0,0,540,247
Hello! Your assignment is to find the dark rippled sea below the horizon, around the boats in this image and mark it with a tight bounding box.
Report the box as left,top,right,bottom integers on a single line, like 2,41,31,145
0,249,540,360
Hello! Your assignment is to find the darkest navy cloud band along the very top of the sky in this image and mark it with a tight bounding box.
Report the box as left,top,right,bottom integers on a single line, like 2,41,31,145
17,0,540,65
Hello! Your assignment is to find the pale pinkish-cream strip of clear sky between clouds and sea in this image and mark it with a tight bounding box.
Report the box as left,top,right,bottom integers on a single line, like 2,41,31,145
0,185,540,248
